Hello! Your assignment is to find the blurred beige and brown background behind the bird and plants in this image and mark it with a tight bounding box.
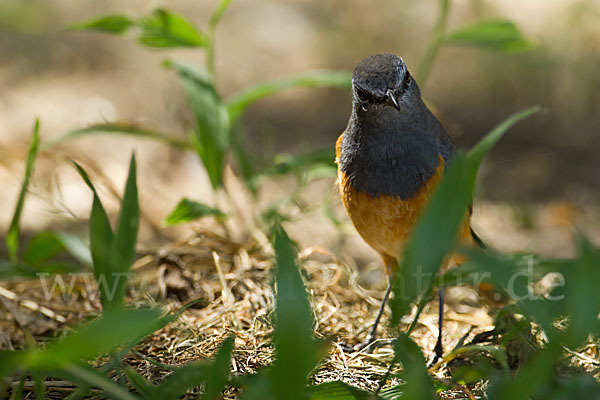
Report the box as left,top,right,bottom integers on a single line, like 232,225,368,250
0,0,600,264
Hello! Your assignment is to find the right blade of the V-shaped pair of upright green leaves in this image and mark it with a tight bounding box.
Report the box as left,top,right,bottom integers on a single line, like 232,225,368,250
109,155,140,307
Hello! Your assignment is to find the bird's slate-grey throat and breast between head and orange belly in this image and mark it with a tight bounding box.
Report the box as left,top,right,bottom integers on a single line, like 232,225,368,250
339,104,452,199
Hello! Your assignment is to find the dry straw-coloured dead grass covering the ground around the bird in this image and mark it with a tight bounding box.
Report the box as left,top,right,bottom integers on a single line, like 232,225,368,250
0,223,600,398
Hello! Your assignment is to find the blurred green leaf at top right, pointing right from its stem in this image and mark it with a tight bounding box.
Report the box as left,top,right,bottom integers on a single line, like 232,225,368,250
445,20,533,52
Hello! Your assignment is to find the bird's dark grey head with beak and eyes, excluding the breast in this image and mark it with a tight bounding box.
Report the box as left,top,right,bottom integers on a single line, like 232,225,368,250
352,53,421,114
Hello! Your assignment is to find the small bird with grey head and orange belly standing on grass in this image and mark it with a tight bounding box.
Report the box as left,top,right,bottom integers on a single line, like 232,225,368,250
336,53,480,359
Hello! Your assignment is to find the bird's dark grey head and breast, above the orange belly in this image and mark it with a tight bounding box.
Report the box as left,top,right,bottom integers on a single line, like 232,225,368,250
338,54,452,199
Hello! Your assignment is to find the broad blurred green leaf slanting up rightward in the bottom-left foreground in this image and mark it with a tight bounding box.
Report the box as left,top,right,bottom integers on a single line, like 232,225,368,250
21,309,162,369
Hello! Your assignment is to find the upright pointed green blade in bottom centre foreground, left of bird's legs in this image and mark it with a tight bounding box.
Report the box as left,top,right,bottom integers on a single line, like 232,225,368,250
269,224,320,399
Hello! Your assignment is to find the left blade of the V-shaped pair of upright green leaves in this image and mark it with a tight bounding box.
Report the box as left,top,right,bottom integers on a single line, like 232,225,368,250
73,162,115,309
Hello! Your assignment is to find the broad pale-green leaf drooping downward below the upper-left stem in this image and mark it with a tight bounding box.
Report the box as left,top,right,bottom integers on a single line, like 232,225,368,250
166,62,230,189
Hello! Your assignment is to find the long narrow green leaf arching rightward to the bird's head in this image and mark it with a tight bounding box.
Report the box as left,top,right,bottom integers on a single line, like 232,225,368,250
227,71,352,123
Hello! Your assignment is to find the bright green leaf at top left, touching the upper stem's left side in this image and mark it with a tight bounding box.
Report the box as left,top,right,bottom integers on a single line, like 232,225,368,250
138,8,207,48
